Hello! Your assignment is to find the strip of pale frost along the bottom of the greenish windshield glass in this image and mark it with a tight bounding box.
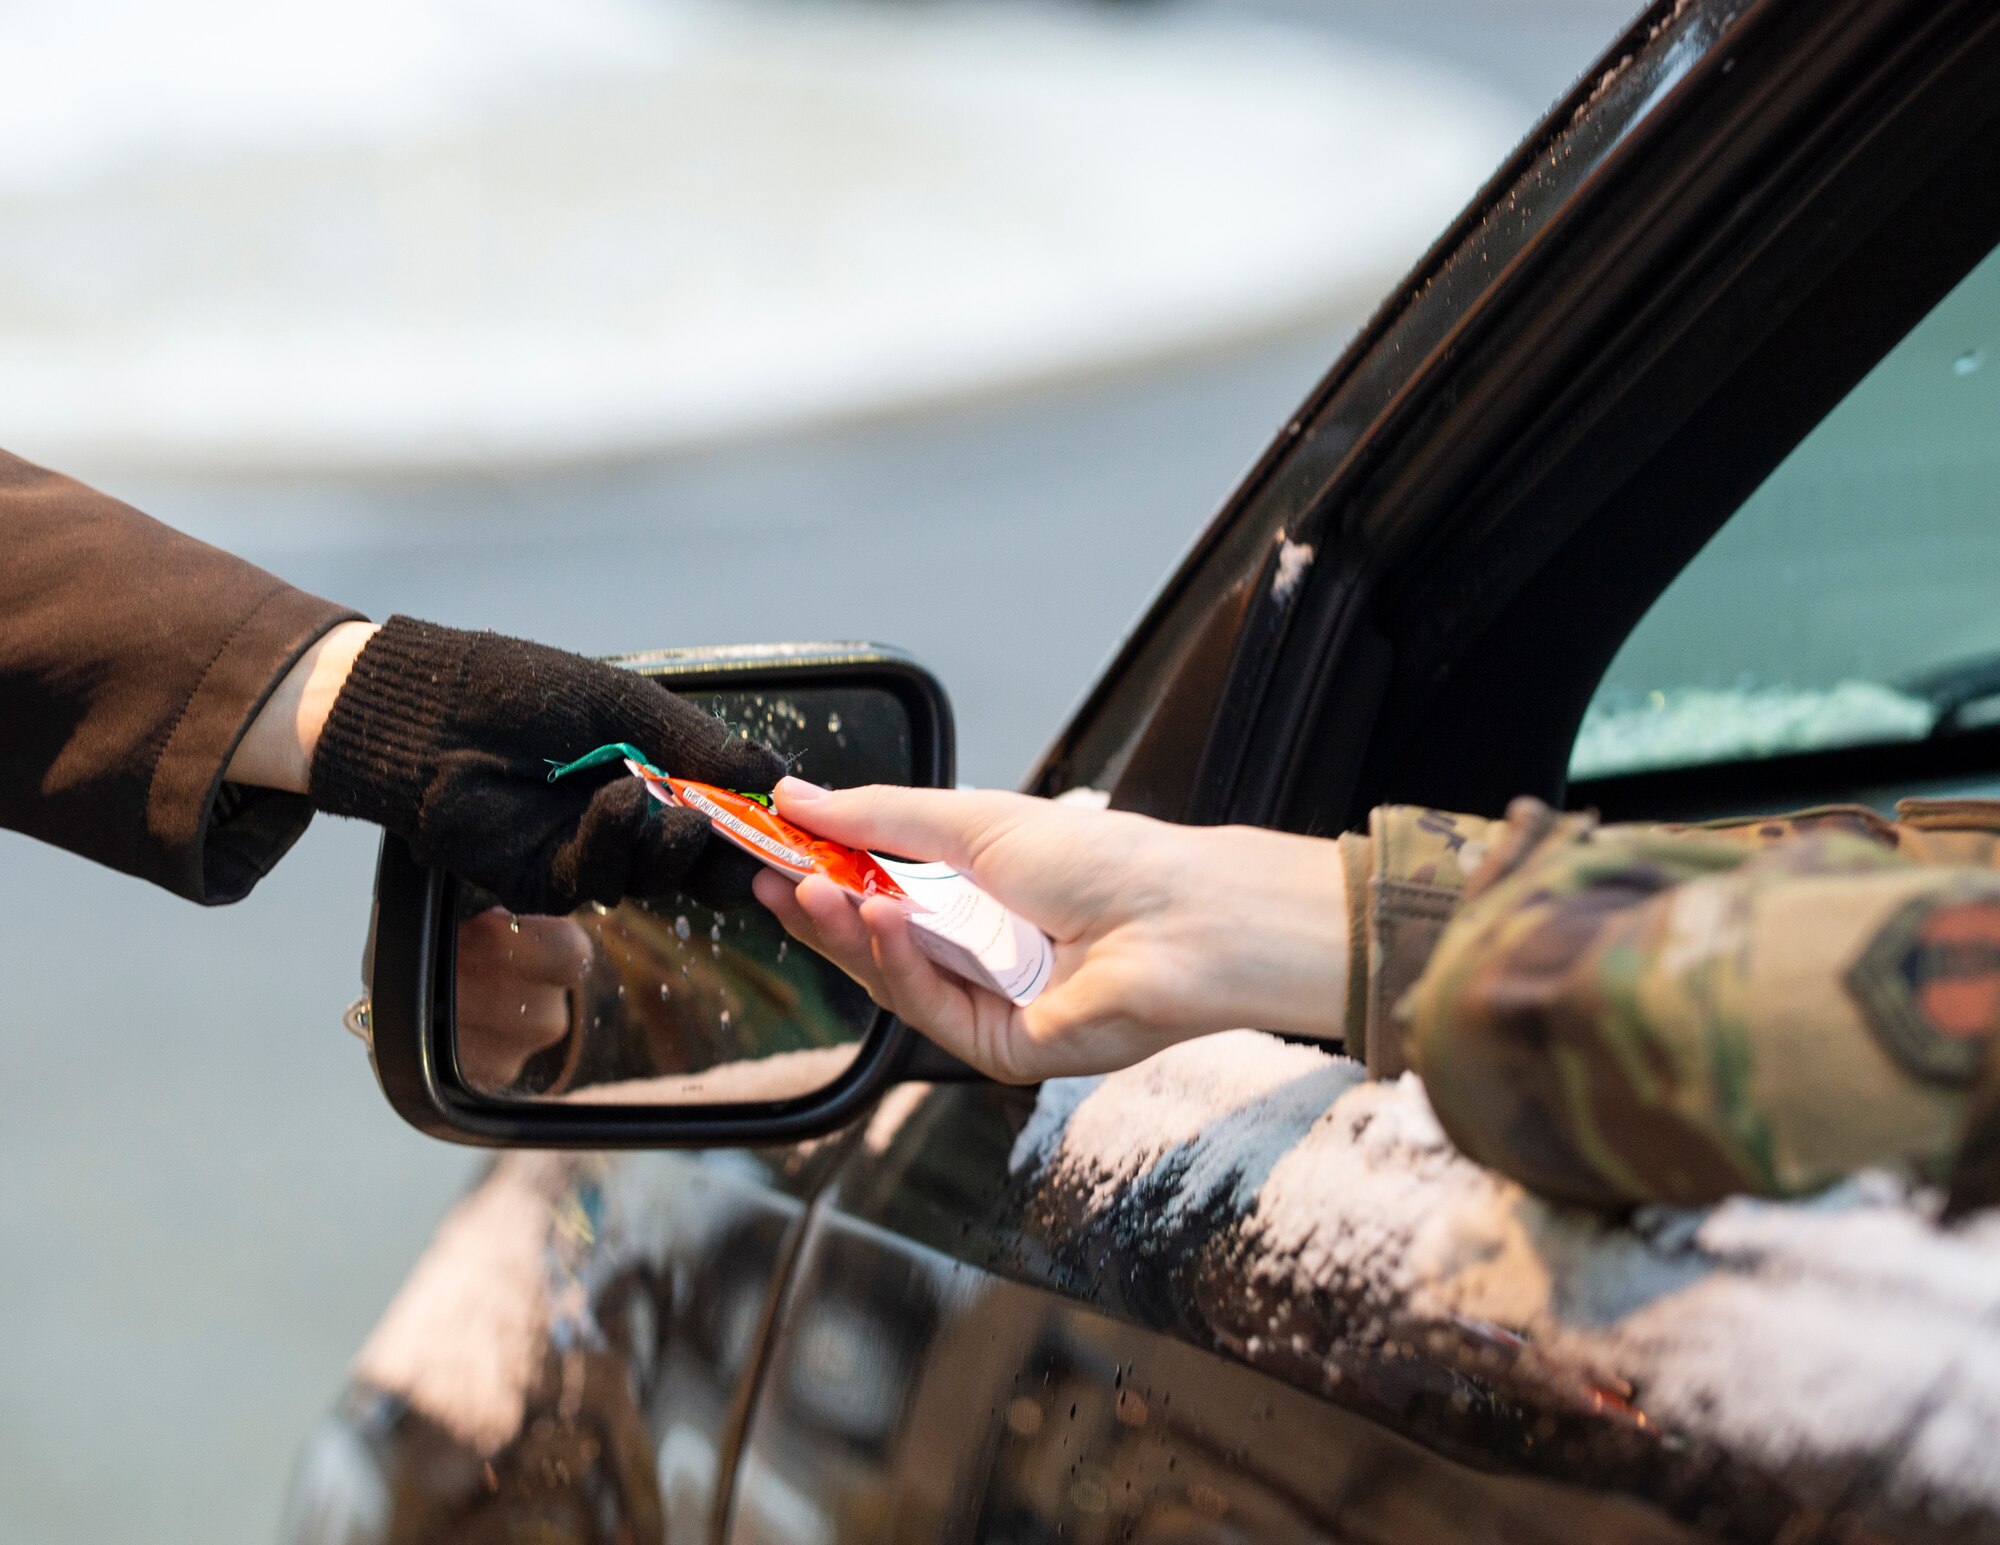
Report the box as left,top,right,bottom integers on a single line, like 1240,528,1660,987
1570,680,1938,779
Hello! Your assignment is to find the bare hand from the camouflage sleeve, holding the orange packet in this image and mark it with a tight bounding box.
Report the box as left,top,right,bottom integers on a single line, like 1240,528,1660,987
756,779,1348,1083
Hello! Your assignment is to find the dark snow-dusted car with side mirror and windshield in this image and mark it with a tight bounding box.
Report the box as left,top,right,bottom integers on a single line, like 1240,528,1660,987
286,0,2000,1545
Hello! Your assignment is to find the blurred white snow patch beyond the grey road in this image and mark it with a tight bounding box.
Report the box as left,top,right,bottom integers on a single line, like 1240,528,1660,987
0,0,1522,472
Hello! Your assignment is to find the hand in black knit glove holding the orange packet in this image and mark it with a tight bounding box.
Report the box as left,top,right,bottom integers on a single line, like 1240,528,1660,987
308,616,784,913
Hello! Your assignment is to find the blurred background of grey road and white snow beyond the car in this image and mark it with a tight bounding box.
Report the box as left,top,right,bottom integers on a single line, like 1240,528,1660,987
0,0,1630,1545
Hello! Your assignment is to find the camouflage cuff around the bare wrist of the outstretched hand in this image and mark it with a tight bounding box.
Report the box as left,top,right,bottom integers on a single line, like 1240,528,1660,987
1340,805,1506,1079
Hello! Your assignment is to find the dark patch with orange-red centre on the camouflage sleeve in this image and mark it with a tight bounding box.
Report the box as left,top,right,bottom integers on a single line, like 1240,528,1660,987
1846,889,2000,1089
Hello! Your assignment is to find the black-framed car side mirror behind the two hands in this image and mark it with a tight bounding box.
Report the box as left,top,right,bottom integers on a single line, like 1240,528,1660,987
370,644,974,1149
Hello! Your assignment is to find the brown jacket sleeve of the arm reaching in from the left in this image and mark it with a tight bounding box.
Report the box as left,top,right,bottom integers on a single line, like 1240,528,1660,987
0,452,356,905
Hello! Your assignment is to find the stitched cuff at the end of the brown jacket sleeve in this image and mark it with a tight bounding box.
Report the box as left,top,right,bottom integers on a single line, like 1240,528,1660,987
138,586,362,907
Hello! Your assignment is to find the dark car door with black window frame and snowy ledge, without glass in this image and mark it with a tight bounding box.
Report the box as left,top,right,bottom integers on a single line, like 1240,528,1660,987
724,4,2000,1543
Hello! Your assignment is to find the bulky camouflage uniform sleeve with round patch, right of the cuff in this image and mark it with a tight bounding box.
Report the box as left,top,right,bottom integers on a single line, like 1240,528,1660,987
1400,801,2000,1205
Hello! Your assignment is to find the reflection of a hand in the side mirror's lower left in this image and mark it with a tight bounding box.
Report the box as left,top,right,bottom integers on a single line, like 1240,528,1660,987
454,907,592,1095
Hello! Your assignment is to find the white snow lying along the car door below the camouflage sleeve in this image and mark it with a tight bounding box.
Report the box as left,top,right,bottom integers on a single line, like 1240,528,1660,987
1012,1031,2000,1513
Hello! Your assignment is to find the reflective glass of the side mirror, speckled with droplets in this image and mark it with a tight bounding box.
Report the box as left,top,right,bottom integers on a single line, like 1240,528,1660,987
452,686,914,1105
